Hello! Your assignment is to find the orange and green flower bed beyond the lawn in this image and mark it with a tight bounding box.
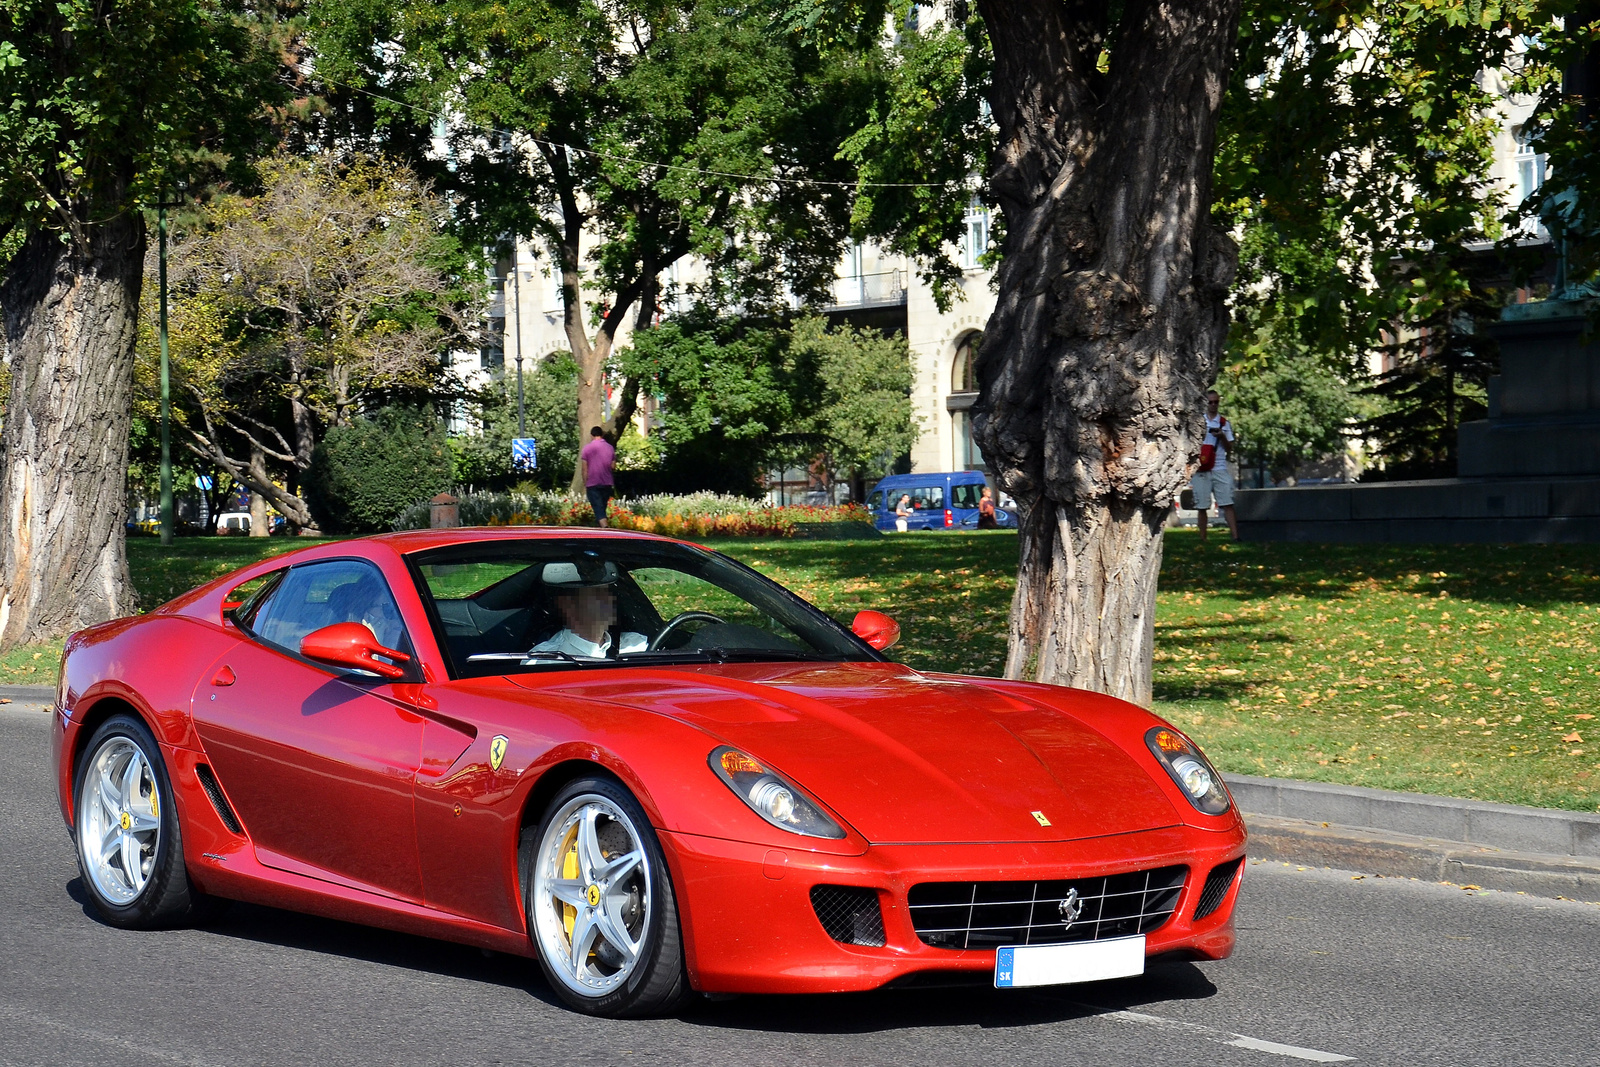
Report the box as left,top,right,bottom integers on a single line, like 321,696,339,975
394,491,872,537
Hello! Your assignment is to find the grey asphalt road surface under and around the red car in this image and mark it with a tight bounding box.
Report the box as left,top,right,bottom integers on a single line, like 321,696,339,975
0,704,1600,1067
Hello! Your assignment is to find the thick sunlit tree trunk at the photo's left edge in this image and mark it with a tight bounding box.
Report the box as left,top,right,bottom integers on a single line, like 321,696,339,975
0,220,144,648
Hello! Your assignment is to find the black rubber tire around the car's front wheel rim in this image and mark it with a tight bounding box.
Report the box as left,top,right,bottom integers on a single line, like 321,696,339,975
518,777,693,1019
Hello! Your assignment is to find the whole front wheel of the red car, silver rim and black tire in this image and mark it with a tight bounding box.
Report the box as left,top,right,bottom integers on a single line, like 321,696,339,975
522,777,691,1017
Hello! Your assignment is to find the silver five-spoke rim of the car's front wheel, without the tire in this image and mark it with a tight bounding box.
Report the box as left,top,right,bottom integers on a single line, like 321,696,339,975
530,793,653,997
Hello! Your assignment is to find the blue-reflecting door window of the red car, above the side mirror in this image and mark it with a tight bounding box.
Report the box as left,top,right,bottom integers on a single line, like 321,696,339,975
250,560,410,653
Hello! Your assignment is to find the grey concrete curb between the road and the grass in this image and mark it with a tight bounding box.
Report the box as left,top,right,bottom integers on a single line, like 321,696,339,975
9,686,1600,901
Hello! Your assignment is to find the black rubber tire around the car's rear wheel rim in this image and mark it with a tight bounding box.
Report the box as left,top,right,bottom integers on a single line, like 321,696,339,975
72,715,221,929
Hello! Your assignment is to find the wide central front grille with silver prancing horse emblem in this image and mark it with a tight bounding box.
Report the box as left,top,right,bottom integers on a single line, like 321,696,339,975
909,865,1189,949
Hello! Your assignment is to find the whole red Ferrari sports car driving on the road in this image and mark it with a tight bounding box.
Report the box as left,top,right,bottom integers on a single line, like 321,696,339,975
53,528,1245,1016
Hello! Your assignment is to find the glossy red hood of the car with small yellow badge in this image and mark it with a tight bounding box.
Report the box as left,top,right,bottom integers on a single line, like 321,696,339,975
512,662,1181,845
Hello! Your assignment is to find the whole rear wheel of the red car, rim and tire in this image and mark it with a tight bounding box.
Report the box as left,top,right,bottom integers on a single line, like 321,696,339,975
74,715,210,929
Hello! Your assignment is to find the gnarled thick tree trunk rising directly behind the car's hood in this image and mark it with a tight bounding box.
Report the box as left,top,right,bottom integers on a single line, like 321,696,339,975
973,0,1238,704
